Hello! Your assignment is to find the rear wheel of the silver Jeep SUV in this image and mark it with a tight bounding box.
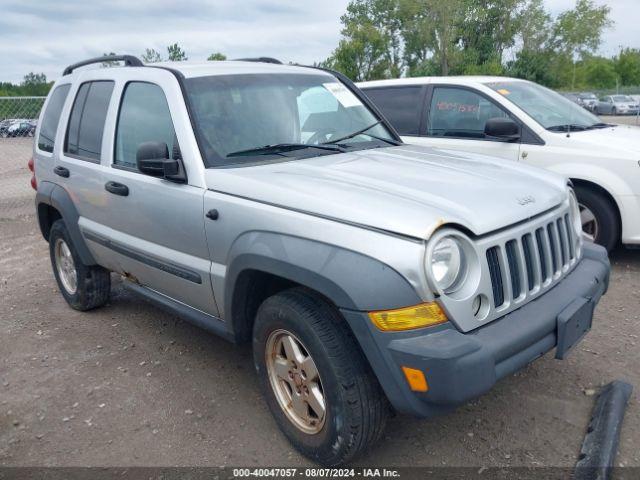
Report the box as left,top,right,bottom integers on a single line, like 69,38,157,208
49,220,111,311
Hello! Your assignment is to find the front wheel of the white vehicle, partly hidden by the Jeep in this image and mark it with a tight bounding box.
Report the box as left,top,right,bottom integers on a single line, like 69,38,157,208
575,186,620,252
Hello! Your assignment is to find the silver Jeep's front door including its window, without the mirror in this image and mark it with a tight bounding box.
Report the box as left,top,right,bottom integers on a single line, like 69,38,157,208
83,75,218,315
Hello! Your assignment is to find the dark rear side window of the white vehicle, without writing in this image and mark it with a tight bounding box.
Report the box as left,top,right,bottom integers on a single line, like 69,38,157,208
365,86,423,135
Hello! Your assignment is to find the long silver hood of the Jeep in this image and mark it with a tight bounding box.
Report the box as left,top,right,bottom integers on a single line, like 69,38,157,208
206,145,567,239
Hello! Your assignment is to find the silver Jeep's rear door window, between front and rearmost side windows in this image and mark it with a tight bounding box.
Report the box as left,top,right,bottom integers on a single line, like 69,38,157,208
64,80,113,162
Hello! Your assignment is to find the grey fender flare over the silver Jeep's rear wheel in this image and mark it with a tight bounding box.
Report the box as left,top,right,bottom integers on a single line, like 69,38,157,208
36,182,97,266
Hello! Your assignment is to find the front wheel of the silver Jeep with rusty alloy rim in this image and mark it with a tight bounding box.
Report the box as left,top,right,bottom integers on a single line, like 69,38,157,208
253,288,389,466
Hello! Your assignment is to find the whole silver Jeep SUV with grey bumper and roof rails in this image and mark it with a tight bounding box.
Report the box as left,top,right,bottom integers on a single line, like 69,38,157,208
33,56,609,465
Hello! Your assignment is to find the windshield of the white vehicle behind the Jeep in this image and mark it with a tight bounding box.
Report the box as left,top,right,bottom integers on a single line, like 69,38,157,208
486,81,600,129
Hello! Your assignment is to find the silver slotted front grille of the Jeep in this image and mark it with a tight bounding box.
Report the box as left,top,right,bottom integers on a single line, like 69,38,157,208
486,208,576,311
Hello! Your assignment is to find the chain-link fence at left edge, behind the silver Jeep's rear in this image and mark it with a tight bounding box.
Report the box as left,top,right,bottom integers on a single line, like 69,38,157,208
0,97,45,221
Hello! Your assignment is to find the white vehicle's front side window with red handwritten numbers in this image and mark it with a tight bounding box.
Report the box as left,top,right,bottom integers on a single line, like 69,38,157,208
427,87,509,140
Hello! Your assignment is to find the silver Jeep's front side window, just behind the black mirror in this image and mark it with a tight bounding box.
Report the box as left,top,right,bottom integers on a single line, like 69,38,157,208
113,82,177,168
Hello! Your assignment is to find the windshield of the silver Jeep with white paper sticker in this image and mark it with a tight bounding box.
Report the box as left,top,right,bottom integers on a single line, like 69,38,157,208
185,73,396,166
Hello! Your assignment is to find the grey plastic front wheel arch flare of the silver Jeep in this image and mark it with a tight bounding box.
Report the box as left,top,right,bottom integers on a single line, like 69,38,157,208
223,232,421,343
